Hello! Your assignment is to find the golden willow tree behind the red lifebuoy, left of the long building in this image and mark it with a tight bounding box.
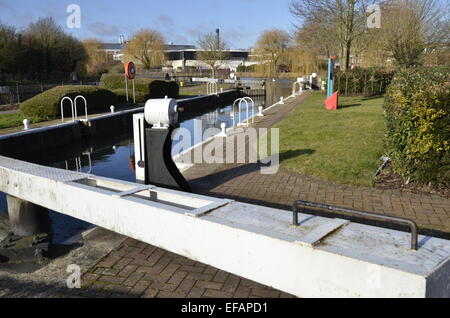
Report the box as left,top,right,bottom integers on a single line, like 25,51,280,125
125,29,166,69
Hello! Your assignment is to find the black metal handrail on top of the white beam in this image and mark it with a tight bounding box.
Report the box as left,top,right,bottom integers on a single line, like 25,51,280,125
293,200,418,250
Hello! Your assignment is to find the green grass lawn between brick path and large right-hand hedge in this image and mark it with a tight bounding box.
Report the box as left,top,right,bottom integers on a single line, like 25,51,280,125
277,92,386,186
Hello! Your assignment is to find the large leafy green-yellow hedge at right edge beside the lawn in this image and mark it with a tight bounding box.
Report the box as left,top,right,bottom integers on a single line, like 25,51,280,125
384,66,450,185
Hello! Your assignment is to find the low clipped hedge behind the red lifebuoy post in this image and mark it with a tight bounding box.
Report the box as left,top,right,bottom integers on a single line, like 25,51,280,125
100,74,179,98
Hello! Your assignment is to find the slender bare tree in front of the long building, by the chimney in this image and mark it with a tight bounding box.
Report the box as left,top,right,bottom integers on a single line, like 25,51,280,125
197,32,229,78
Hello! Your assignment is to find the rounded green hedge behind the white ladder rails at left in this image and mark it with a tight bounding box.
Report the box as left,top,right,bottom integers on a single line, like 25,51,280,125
20,85,117,120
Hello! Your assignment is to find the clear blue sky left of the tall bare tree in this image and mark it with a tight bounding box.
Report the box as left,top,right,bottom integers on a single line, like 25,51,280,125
0,0,295,49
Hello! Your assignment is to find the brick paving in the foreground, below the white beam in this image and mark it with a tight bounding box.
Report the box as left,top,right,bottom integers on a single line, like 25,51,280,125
74,239,293,298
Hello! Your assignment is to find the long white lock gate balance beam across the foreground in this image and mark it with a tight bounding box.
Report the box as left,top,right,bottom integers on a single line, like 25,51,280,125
0,157,450,297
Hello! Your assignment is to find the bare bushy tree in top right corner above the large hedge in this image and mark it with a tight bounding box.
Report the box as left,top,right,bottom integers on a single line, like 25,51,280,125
380,0,450,67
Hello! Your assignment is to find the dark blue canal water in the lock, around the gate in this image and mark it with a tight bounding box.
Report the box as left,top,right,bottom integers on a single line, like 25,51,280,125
0,80,292,244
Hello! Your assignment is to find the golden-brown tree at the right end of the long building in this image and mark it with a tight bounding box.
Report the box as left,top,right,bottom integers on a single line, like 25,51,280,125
256,29,290,74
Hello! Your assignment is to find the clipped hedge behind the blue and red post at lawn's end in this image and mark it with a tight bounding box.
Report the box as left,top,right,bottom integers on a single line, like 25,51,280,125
334,68,394,95
